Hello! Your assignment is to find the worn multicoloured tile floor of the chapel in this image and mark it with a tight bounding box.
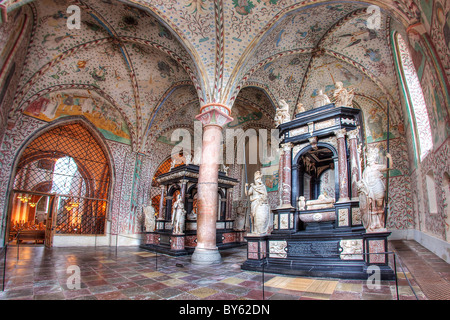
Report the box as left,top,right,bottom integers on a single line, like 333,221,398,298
0,241,450,300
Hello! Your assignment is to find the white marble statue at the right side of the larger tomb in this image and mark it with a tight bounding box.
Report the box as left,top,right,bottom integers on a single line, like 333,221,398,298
357,148,392,233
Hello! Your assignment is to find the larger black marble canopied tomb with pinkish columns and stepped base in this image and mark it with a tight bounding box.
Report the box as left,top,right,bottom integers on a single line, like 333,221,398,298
242,104,394,279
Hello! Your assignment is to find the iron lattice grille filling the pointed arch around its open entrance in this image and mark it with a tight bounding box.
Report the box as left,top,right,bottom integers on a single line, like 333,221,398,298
12,124,110,235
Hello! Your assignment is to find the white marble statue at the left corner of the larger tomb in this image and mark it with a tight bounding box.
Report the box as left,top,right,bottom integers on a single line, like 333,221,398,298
245,171,273,235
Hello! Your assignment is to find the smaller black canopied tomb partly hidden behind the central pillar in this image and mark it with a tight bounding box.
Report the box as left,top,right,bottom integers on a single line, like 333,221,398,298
141,164,243,256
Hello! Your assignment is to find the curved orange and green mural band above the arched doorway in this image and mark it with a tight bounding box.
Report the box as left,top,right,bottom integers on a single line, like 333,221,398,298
23,90,131,144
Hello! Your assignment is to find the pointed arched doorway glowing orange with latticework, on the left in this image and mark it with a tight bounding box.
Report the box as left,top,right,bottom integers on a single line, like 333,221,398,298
9,123,111,246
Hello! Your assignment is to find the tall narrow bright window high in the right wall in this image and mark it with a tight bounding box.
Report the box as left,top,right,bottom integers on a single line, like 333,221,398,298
395,33,433,161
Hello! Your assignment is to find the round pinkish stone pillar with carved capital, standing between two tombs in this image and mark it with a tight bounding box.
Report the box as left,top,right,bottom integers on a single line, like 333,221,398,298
191,103,233,265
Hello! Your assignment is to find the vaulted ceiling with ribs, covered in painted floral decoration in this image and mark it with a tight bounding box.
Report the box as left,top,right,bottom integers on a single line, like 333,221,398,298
3,0,416,152
